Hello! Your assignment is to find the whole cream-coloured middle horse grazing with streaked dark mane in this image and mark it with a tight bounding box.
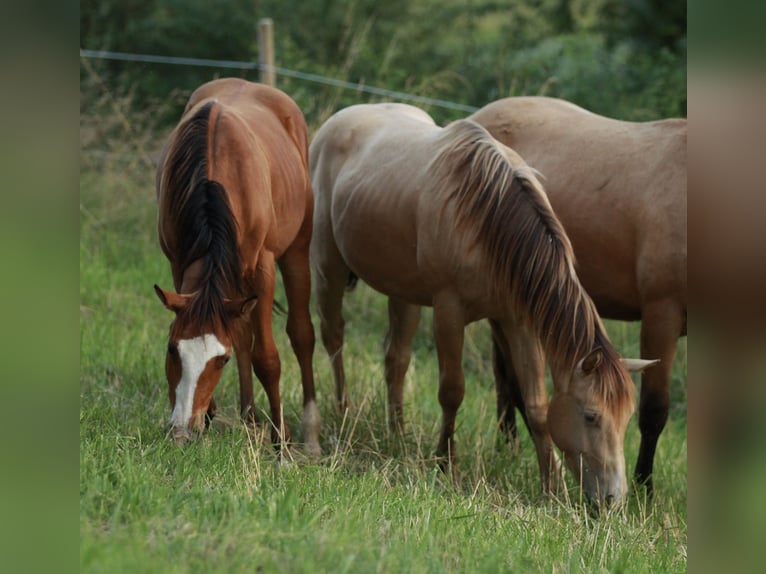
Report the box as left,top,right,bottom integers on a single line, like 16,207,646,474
309,104,656,508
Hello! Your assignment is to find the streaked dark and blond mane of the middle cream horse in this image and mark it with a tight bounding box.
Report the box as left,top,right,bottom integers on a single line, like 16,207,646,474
429,120,634,413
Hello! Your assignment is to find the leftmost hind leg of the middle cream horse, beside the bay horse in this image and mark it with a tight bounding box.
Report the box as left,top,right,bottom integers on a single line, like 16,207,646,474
311,236,351,414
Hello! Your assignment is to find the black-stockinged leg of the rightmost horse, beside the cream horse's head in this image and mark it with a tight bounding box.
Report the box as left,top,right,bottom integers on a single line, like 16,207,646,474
635,300,684,494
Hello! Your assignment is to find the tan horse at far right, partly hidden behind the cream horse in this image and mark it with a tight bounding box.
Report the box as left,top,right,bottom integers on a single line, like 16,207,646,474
471,97,686,492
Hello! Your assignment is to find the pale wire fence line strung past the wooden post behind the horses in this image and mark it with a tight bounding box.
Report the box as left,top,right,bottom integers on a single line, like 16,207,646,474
80,49,479,113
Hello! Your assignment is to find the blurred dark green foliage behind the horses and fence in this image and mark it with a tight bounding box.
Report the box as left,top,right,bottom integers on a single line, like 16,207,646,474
80,0,686,124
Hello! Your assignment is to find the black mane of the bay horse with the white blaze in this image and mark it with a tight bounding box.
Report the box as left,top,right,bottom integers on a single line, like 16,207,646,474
160,101,241,325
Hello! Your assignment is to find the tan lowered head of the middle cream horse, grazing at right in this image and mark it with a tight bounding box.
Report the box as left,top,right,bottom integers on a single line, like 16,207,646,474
548,347,659,506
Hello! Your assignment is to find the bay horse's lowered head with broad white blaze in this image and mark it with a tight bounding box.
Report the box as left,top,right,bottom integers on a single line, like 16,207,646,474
154,285,256,444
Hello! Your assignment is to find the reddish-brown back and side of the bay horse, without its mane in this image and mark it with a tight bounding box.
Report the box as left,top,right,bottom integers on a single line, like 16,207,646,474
178,78,313,264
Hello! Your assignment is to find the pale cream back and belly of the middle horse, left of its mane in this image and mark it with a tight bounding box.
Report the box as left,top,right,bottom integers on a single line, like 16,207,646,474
310,104,520,316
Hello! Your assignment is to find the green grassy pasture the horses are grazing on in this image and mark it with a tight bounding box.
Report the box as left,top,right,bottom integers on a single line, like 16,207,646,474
80,137,687,573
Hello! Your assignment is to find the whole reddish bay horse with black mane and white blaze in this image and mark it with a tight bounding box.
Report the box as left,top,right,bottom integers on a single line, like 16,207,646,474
155,79,320,454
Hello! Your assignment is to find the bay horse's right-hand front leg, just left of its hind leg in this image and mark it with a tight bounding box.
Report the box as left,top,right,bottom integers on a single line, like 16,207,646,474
251,253,290,446
